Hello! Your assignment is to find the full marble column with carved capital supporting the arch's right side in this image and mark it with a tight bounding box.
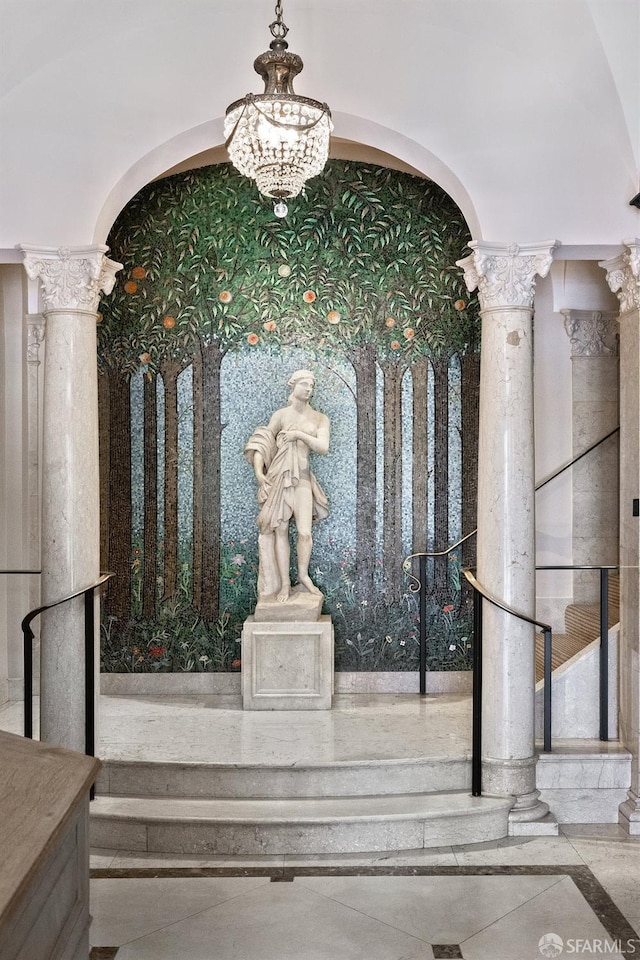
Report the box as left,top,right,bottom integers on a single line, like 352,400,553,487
459,241,555,834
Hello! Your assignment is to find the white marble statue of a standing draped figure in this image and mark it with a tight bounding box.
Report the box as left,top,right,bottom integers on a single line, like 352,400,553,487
244,370,329,615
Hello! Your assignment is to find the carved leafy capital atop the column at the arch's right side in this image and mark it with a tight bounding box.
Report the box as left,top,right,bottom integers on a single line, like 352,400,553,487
457,240,557,310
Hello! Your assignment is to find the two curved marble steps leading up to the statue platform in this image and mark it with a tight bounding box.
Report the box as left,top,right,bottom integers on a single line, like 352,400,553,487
91,756,511,856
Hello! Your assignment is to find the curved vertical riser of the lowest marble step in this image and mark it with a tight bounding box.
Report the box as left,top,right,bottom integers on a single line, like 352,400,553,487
91,808,508,857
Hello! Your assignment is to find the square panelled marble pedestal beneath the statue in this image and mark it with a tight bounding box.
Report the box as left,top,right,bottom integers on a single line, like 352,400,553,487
242,616,334,710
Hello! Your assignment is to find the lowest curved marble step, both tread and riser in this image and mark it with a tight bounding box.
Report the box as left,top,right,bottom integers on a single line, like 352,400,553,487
91,791,512,855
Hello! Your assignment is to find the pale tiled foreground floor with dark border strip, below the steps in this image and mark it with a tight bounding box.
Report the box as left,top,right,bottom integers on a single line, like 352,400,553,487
91,825,640,960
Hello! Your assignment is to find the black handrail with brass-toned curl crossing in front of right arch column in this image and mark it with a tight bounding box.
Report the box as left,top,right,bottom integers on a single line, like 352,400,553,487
462,569,551,797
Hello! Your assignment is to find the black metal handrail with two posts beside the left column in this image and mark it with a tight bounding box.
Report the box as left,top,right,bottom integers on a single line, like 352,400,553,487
21,573,115,757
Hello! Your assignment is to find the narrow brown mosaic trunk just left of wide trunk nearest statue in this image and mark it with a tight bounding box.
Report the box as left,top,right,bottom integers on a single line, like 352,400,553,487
160,360,184,600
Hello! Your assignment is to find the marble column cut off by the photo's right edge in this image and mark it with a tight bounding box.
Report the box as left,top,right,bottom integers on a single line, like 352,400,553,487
600,239,640,836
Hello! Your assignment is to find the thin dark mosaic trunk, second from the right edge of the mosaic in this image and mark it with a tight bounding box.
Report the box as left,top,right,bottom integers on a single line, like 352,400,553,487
431,356,449,602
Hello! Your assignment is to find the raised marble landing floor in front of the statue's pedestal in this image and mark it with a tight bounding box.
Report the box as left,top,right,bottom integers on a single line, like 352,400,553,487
0,693,471,765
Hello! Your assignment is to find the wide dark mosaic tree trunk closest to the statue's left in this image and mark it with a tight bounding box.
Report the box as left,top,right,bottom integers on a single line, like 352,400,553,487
201,340,225,620
